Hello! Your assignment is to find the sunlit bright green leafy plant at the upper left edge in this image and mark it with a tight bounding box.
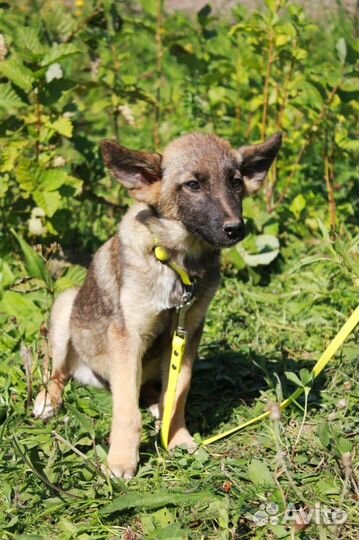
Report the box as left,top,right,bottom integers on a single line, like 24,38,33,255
0,21,82,236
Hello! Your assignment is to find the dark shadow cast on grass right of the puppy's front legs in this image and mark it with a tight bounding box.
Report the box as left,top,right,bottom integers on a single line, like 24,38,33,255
187,344,326,437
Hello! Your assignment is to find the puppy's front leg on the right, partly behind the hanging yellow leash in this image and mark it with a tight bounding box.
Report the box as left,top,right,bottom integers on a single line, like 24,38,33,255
161,323,203,451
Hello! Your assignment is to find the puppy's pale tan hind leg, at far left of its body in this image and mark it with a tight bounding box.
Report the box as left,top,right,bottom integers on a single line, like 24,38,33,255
33,289,78,420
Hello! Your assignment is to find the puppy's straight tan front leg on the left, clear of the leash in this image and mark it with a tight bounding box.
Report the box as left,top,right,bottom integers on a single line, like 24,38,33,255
107,325,142,478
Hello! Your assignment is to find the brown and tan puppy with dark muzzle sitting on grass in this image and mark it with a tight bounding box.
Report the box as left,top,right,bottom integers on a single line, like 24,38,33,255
34,134,281,478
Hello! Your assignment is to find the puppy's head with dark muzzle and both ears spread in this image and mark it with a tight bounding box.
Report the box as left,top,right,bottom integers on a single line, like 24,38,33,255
101,133,282,248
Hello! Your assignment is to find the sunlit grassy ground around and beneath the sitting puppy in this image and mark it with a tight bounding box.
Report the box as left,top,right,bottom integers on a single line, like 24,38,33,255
0,233,359,540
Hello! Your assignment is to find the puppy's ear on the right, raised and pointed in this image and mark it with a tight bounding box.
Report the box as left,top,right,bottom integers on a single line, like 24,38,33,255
238,133,282,195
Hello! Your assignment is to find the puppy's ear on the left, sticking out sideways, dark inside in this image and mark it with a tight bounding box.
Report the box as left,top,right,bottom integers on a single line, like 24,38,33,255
101,140,162,205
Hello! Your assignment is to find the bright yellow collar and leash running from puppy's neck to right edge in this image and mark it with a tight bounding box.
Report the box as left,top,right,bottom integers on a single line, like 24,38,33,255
154,246,359,450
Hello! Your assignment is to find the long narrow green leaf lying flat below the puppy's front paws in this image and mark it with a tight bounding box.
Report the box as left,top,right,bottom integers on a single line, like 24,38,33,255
100,491,214,515
